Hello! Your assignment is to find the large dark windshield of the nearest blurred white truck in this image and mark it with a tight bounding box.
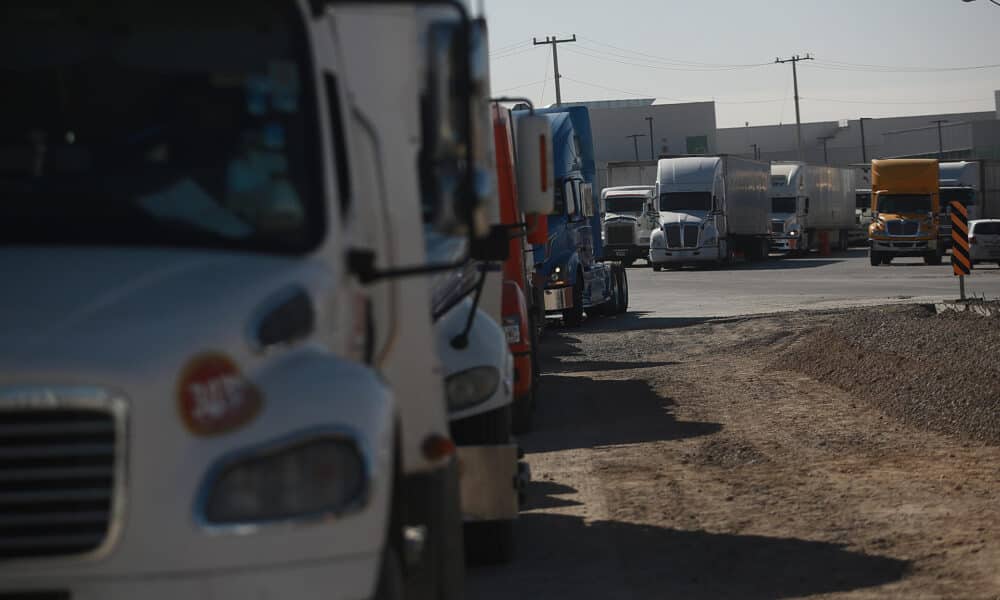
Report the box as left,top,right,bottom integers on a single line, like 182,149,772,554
0,0,323,253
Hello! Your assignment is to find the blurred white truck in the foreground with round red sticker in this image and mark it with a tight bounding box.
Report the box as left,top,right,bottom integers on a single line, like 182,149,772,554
0,0,508,600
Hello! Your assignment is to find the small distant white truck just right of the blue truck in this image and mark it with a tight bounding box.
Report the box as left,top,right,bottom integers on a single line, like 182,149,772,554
601,185,660,267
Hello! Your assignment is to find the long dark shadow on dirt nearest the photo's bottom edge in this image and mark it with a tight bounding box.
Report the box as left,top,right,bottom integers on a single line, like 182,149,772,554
468,513,909,600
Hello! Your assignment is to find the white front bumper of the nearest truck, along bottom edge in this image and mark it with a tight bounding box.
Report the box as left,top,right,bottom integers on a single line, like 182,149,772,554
0,552,380,600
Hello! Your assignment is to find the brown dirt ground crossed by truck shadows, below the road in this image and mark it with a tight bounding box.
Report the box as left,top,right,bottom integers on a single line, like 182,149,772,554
469,311,1000,600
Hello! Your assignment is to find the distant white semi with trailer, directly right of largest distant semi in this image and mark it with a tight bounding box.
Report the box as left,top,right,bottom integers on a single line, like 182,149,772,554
770,162,857,254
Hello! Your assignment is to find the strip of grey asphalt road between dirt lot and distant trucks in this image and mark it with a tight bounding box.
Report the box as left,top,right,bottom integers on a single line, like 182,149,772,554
628,250,1000,317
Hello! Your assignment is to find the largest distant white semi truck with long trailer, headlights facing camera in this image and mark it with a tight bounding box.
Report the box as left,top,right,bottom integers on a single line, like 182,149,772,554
649,156,771,271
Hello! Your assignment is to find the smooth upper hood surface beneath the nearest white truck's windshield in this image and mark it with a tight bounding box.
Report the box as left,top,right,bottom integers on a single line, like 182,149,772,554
0,248,314,367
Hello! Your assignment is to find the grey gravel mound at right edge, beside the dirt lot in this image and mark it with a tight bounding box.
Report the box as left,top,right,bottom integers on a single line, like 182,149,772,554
772,306,1000,444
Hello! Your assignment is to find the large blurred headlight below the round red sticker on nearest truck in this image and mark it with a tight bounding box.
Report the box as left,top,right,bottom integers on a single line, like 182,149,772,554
203,437,368,525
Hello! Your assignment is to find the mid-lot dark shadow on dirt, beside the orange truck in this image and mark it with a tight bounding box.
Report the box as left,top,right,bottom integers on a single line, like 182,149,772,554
520,375,722,452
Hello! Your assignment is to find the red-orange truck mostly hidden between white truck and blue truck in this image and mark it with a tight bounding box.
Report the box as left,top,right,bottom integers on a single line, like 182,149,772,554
493,104,552,433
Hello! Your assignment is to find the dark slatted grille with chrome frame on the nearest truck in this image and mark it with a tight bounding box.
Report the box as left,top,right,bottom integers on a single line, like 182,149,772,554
0,394,124,561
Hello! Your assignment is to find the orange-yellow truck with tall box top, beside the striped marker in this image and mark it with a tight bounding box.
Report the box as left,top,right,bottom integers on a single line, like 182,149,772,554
868,159,944,267
